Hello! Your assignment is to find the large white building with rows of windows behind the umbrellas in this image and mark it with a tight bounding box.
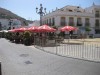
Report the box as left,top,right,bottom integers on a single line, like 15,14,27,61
42,4,100,37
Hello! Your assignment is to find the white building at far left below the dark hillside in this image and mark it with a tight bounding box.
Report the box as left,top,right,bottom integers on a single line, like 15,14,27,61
0,19,21,30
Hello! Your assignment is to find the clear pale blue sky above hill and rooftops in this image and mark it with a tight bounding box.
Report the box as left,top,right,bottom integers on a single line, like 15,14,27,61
0,0,100,20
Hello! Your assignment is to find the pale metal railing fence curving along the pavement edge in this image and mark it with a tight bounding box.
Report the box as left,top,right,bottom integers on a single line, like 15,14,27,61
34,37,100,62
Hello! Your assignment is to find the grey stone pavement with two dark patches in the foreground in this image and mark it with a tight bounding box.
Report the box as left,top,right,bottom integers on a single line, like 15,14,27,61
0,39,100,75
